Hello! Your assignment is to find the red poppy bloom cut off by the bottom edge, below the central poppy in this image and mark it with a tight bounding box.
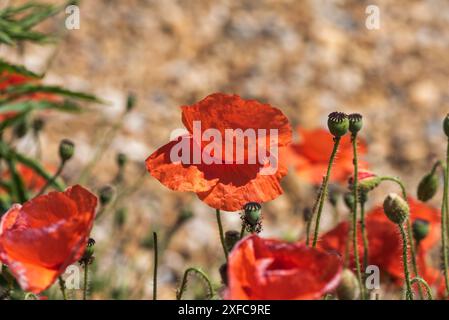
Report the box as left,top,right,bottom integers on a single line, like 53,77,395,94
226,235,342,300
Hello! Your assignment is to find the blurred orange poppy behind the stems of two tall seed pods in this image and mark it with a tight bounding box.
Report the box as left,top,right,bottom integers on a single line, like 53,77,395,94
289,127,367,184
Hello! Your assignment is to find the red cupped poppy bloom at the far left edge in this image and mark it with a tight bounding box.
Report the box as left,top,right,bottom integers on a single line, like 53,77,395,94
0,185,97,294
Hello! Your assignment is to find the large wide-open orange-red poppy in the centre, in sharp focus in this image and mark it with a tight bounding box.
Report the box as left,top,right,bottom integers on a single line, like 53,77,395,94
146,93,291,211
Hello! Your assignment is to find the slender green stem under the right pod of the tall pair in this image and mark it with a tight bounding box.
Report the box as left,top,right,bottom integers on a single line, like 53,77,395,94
351,134,366,300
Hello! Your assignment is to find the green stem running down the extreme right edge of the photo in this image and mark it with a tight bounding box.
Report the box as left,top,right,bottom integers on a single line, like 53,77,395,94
441,140,449,296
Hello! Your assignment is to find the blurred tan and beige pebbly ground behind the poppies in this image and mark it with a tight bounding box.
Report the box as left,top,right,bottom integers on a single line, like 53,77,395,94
0,0,449,299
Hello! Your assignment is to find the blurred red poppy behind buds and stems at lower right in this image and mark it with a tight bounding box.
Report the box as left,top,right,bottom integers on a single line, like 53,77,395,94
319,198,440,285
